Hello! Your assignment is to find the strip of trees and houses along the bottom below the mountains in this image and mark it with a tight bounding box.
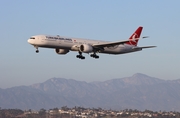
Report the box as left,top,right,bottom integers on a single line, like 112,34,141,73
0,106,180,118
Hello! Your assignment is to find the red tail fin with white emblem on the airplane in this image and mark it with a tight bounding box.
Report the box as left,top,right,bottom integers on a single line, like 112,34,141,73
126,27,143,46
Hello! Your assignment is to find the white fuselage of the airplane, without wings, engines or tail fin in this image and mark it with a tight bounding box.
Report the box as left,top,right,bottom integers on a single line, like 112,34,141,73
28,35,140,54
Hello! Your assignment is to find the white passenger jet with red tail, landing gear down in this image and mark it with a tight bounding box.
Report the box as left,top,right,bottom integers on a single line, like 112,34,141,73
28,26,156,59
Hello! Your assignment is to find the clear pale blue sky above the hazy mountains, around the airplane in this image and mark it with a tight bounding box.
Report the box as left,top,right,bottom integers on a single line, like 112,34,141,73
0,0,180,88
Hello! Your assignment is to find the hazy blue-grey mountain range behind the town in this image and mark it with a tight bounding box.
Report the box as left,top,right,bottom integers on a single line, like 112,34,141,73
0,73,180,111
